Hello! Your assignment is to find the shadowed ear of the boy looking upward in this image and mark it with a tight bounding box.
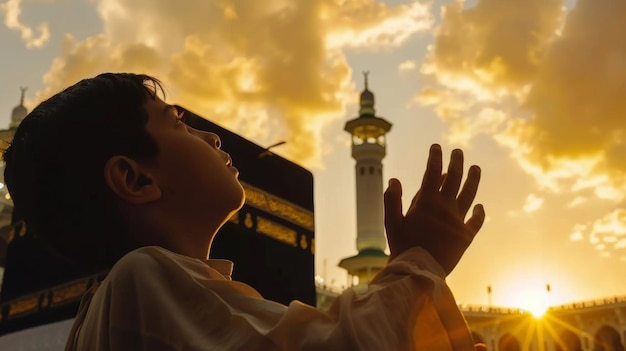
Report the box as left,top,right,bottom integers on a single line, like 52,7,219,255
104,155,161,205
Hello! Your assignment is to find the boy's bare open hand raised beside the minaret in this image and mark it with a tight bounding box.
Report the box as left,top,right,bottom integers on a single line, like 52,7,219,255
385,144,485,274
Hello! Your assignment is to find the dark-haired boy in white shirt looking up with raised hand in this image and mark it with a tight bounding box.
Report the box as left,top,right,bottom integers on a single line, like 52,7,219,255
4,73,485,350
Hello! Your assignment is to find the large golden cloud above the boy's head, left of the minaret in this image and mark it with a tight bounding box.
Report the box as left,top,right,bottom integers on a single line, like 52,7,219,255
33,0,431,166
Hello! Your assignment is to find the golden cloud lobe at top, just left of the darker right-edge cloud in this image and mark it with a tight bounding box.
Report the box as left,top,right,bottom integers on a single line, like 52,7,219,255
425,0,563,97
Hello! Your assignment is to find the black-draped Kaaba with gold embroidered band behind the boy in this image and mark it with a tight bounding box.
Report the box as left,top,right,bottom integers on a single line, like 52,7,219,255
0,106,315,335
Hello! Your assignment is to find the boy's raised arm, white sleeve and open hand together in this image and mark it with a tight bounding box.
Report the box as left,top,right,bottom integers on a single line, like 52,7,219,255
268,145,485,351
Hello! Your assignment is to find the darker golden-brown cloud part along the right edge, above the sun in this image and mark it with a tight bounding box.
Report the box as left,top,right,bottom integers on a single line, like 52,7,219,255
525,0,626,200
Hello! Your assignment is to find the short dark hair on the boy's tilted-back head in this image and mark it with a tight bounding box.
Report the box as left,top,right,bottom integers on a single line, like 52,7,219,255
4,73,163,268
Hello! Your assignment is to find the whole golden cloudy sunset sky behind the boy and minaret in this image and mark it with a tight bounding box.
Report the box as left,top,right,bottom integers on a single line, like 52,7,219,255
0,0,626,308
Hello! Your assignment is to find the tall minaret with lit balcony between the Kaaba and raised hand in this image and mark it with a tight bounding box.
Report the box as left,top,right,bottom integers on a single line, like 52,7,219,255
339,72,391,292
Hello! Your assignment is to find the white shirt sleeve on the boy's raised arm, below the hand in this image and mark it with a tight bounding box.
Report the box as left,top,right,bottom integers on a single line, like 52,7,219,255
268,248,474,351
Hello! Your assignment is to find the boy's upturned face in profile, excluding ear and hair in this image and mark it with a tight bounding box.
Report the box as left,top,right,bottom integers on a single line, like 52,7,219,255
146,98,245,229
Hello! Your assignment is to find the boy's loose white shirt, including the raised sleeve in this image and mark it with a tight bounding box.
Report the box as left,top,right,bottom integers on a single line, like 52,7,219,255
66,246,474,351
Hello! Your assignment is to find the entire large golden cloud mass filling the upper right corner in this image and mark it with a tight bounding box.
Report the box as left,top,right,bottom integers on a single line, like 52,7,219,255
417,0,626,202
